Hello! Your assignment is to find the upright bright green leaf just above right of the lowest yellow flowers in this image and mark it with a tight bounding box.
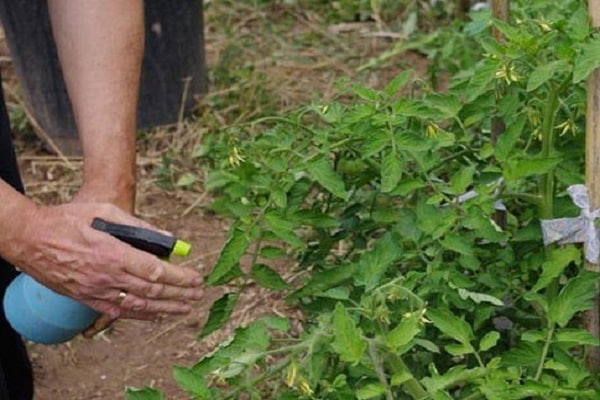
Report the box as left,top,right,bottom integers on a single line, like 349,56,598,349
331,303,367,364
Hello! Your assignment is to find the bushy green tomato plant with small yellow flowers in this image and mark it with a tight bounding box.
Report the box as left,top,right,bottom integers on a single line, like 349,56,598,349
131,0,600,400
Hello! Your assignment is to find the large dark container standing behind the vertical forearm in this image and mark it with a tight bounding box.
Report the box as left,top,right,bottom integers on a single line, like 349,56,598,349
0,0,206,155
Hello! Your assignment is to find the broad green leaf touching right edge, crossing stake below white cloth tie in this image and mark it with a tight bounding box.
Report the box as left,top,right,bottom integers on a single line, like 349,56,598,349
548,271,600,327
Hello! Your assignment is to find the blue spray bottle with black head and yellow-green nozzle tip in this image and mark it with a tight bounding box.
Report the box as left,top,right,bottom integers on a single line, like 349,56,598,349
4,218,191,344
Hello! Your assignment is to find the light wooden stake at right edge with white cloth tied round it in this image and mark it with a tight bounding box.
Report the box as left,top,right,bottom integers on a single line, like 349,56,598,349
584,0,600,372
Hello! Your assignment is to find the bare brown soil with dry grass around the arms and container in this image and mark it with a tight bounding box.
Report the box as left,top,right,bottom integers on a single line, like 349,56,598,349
2,2,426,400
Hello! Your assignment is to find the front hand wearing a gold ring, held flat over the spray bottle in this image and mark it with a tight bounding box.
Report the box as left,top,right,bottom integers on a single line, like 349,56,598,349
1,203,202,326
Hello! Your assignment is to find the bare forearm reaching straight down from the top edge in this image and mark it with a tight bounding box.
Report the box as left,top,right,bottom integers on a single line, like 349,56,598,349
49,0,144,210
